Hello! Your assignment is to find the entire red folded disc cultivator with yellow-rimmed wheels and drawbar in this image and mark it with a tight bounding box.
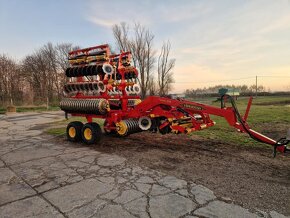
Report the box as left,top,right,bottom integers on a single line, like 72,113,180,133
60,45,290,157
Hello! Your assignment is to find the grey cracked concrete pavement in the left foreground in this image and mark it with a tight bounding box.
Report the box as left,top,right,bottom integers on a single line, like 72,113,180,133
0,112,285,218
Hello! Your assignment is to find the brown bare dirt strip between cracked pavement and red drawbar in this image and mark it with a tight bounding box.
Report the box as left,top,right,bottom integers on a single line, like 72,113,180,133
52,132,290,215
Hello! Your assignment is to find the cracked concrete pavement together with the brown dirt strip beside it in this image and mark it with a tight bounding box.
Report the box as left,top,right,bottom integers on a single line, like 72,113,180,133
0,112,290,218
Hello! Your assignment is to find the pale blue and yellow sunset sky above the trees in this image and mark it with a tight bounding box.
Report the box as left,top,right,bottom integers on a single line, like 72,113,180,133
0,0,290,93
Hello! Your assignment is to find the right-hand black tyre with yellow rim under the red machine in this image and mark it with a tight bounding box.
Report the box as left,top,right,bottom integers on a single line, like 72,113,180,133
82,123,102,145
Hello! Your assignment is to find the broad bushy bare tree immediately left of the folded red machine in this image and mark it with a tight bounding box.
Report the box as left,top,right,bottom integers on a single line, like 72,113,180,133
22,43,74,105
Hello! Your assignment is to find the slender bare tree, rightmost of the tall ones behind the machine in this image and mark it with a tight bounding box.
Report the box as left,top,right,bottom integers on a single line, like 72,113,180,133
157,41,175,96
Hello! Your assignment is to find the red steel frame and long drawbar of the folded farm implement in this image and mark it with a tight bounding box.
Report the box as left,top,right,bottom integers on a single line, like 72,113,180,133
63,45,290,157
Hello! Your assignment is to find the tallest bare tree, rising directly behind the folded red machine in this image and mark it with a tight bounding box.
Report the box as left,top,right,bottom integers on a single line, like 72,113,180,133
113,23,156,98
